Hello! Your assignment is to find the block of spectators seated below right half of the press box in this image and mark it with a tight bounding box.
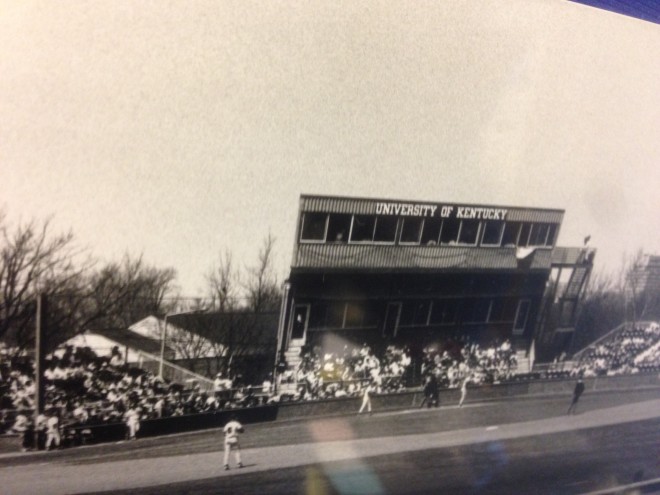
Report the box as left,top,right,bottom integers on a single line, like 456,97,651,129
422,339,517,388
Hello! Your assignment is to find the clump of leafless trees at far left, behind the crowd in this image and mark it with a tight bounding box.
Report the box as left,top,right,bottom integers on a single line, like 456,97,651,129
0,216,176,352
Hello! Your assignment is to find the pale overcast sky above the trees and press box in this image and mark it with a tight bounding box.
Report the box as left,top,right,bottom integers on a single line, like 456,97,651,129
0,0,660,296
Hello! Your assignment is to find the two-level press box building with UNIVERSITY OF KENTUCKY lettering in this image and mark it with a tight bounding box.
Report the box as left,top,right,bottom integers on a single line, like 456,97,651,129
278,195,595,376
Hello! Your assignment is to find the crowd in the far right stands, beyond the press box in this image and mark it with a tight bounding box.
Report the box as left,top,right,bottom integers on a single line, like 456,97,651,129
572,322,660,377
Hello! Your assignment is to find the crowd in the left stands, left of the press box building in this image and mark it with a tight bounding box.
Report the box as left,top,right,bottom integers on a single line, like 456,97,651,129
0,346,268,447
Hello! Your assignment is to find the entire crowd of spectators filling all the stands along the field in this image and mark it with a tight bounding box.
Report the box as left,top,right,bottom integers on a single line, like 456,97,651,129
0,323,660,448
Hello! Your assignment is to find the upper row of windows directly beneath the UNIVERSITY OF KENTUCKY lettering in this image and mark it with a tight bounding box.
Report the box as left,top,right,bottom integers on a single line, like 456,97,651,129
300,212,558,247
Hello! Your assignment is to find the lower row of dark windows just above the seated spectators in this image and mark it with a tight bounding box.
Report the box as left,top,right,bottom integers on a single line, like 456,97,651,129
298,298,530,330
